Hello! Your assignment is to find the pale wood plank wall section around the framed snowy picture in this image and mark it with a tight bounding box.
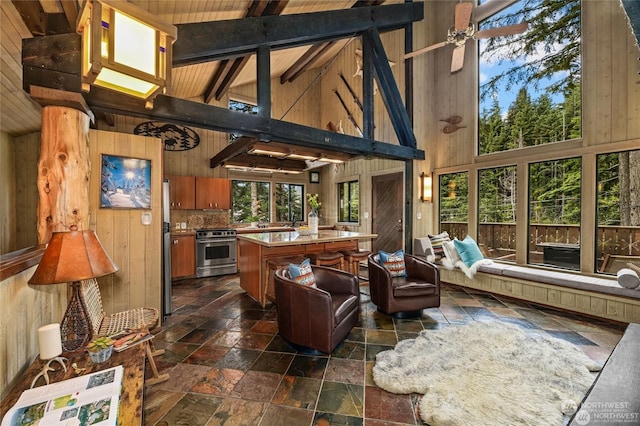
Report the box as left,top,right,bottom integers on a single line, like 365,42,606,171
89,130,163,314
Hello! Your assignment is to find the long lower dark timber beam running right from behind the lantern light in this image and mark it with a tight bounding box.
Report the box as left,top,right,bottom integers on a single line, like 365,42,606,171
85,87,425,160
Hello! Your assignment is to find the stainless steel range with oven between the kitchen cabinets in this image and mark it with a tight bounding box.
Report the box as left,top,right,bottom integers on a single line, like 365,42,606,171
196,229,238,277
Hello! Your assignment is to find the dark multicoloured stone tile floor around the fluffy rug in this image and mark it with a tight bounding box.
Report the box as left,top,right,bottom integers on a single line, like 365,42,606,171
144,275,625,426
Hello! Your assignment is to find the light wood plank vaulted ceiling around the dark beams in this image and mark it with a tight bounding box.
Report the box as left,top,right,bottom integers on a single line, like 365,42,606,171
0,0,402,135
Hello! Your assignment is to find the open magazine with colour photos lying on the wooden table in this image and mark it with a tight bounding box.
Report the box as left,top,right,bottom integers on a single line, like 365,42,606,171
2,365,124,426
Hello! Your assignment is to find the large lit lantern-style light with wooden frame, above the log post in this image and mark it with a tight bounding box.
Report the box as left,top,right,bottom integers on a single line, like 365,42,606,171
77,0,177,109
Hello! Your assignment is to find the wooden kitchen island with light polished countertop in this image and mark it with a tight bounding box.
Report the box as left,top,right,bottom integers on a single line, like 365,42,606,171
238,230,377,306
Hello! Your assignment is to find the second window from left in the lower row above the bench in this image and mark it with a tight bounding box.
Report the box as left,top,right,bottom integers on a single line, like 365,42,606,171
478,166,516,262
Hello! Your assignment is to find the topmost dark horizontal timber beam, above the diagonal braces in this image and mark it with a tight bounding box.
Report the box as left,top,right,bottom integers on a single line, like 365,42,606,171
173,2,424,67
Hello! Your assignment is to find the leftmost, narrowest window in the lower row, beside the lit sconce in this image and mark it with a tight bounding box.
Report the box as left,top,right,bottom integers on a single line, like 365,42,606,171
438,172,469,239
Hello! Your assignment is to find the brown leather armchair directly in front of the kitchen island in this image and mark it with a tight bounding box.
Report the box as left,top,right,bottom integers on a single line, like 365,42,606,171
274,266,360,353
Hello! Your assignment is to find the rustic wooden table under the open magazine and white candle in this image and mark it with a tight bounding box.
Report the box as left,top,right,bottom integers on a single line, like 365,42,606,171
0,345,145,426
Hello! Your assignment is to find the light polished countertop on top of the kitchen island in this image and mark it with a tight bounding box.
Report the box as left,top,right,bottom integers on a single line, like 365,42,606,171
238,230,377,247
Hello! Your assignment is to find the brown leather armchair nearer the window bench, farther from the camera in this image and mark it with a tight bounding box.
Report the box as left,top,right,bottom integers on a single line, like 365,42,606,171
367,253,440,318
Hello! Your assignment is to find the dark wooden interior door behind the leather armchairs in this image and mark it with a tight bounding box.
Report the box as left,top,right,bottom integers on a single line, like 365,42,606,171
371,173,404,252
